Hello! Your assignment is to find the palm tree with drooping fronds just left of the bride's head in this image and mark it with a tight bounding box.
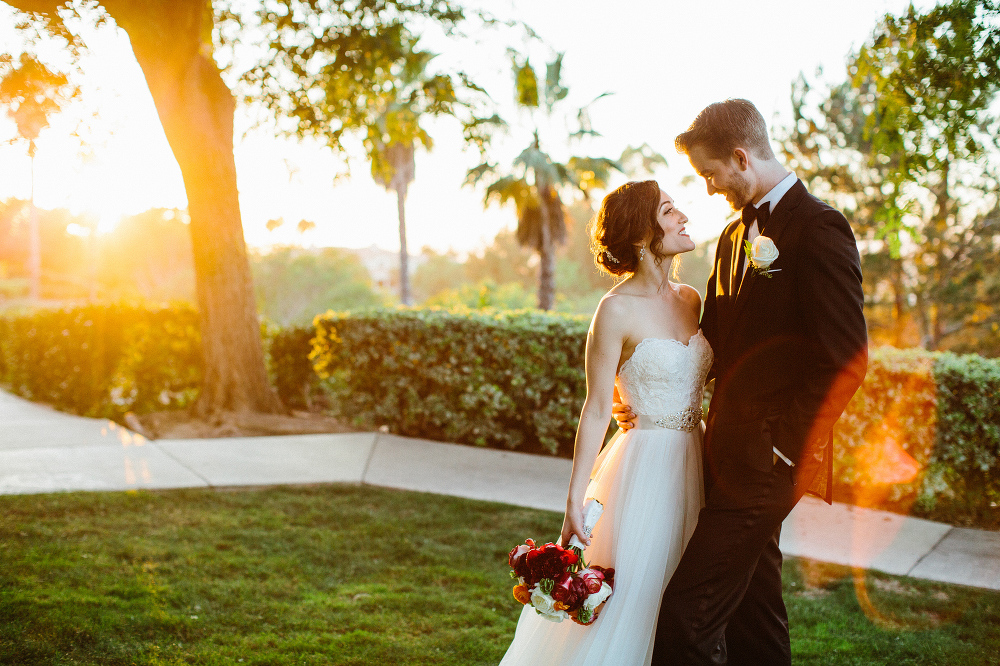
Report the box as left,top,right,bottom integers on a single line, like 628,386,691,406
466,51,632,310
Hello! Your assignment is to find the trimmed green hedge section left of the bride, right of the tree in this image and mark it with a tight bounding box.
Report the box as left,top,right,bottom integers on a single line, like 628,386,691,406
312,309,588,455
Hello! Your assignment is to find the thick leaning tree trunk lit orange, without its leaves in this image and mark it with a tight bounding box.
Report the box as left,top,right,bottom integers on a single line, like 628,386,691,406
102,0,284,416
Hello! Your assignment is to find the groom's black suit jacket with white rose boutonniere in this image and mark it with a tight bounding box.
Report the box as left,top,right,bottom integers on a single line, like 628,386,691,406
702,181,868,502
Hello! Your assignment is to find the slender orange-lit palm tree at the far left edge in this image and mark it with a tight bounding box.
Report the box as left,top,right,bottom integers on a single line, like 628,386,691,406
0,53,79,301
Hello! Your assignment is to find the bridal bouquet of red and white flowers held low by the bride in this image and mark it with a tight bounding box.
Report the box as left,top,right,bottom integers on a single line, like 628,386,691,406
508,500,615,625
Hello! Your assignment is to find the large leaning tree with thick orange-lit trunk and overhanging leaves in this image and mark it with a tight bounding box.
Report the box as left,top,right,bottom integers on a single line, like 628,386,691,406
5,0,496,415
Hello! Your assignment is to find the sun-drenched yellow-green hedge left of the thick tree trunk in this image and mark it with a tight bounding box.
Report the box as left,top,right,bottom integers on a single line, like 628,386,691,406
0,305,202,419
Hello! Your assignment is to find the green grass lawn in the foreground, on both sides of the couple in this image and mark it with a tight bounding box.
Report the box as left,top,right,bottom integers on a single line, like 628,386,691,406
0,486,1000,666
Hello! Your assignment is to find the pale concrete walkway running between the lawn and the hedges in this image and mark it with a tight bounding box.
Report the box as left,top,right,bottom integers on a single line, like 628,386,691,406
0,391,1000,590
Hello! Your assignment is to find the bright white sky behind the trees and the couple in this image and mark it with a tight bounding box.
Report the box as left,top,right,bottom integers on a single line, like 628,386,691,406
0,0,922,255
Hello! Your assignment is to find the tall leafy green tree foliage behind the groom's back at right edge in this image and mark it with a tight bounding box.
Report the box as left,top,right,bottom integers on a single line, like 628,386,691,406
783,0,1000,353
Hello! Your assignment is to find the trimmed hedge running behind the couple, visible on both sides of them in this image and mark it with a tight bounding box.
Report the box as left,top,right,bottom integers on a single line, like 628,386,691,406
312,310,1000,528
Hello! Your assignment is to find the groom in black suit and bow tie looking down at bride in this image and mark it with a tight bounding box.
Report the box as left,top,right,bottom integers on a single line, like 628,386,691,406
616,99,868,666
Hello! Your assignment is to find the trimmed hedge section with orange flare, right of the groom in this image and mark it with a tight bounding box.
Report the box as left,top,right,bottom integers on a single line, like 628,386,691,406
835,348,1000,528
